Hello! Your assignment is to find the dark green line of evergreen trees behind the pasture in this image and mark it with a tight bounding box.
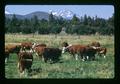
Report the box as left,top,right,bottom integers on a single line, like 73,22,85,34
5,13,114,35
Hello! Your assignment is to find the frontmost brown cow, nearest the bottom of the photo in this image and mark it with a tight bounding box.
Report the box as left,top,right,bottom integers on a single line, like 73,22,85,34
18,52,33,73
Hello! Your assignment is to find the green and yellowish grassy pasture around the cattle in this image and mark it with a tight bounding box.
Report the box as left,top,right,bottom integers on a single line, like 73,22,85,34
5,34,115,79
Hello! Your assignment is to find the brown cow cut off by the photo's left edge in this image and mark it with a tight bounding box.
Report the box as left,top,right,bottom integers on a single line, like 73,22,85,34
5,44,21,63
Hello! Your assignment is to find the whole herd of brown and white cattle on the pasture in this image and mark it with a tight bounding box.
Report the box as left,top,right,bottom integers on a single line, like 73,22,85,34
5,42,107,73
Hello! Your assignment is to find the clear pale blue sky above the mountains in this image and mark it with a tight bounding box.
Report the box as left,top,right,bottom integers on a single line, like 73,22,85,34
5,5,114,19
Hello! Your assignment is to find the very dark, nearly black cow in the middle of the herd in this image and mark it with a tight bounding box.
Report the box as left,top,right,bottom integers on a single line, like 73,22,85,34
43,48,62,62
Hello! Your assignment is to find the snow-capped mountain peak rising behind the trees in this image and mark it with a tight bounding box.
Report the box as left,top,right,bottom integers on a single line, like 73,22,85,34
49,10,74,19
